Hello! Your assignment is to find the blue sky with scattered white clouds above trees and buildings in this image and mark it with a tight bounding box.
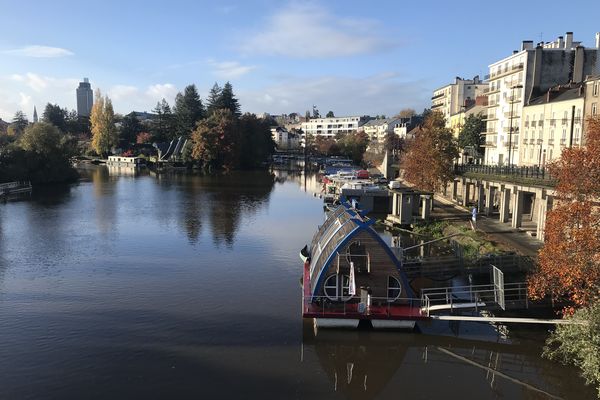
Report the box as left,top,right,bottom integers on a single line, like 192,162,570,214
0,0,600,121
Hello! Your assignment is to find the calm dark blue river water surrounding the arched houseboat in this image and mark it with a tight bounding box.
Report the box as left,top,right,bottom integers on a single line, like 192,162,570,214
0,167,595,399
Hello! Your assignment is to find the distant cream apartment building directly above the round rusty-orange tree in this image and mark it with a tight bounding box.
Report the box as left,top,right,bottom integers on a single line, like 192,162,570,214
431,76,488,124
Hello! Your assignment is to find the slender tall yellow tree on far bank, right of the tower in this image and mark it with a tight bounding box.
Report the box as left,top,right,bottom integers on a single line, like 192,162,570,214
90,90,119,157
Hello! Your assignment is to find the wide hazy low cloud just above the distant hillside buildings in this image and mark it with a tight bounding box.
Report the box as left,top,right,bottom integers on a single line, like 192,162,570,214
238,73,429,115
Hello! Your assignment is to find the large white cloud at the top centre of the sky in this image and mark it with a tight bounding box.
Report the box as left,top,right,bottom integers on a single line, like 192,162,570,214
241,4,393,58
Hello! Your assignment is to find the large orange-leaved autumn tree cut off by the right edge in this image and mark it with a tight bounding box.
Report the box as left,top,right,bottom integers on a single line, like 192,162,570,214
529,117,600,313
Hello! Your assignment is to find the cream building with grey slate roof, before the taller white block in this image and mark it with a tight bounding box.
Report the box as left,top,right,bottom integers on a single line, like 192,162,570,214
515,84,584,168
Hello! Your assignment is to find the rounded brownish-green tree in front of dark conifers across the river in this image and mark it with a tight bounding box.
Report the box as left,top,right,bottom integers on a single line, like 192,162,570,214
192,109,240,171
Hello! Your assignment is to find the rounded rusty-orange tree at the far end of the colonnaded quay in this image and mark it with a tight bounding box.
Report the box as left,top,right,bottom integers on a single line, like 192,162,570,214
401,112,458,191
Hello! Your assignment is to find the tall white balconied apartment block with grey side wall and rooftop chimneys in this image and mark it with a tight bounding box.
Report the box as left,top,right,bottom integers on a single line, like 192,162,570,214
484,32,600,165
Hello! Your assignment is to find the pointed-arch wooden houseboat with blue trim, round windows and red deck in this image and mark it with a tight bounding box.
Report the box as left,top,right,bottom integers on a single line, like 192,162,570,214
301,201,426,329
